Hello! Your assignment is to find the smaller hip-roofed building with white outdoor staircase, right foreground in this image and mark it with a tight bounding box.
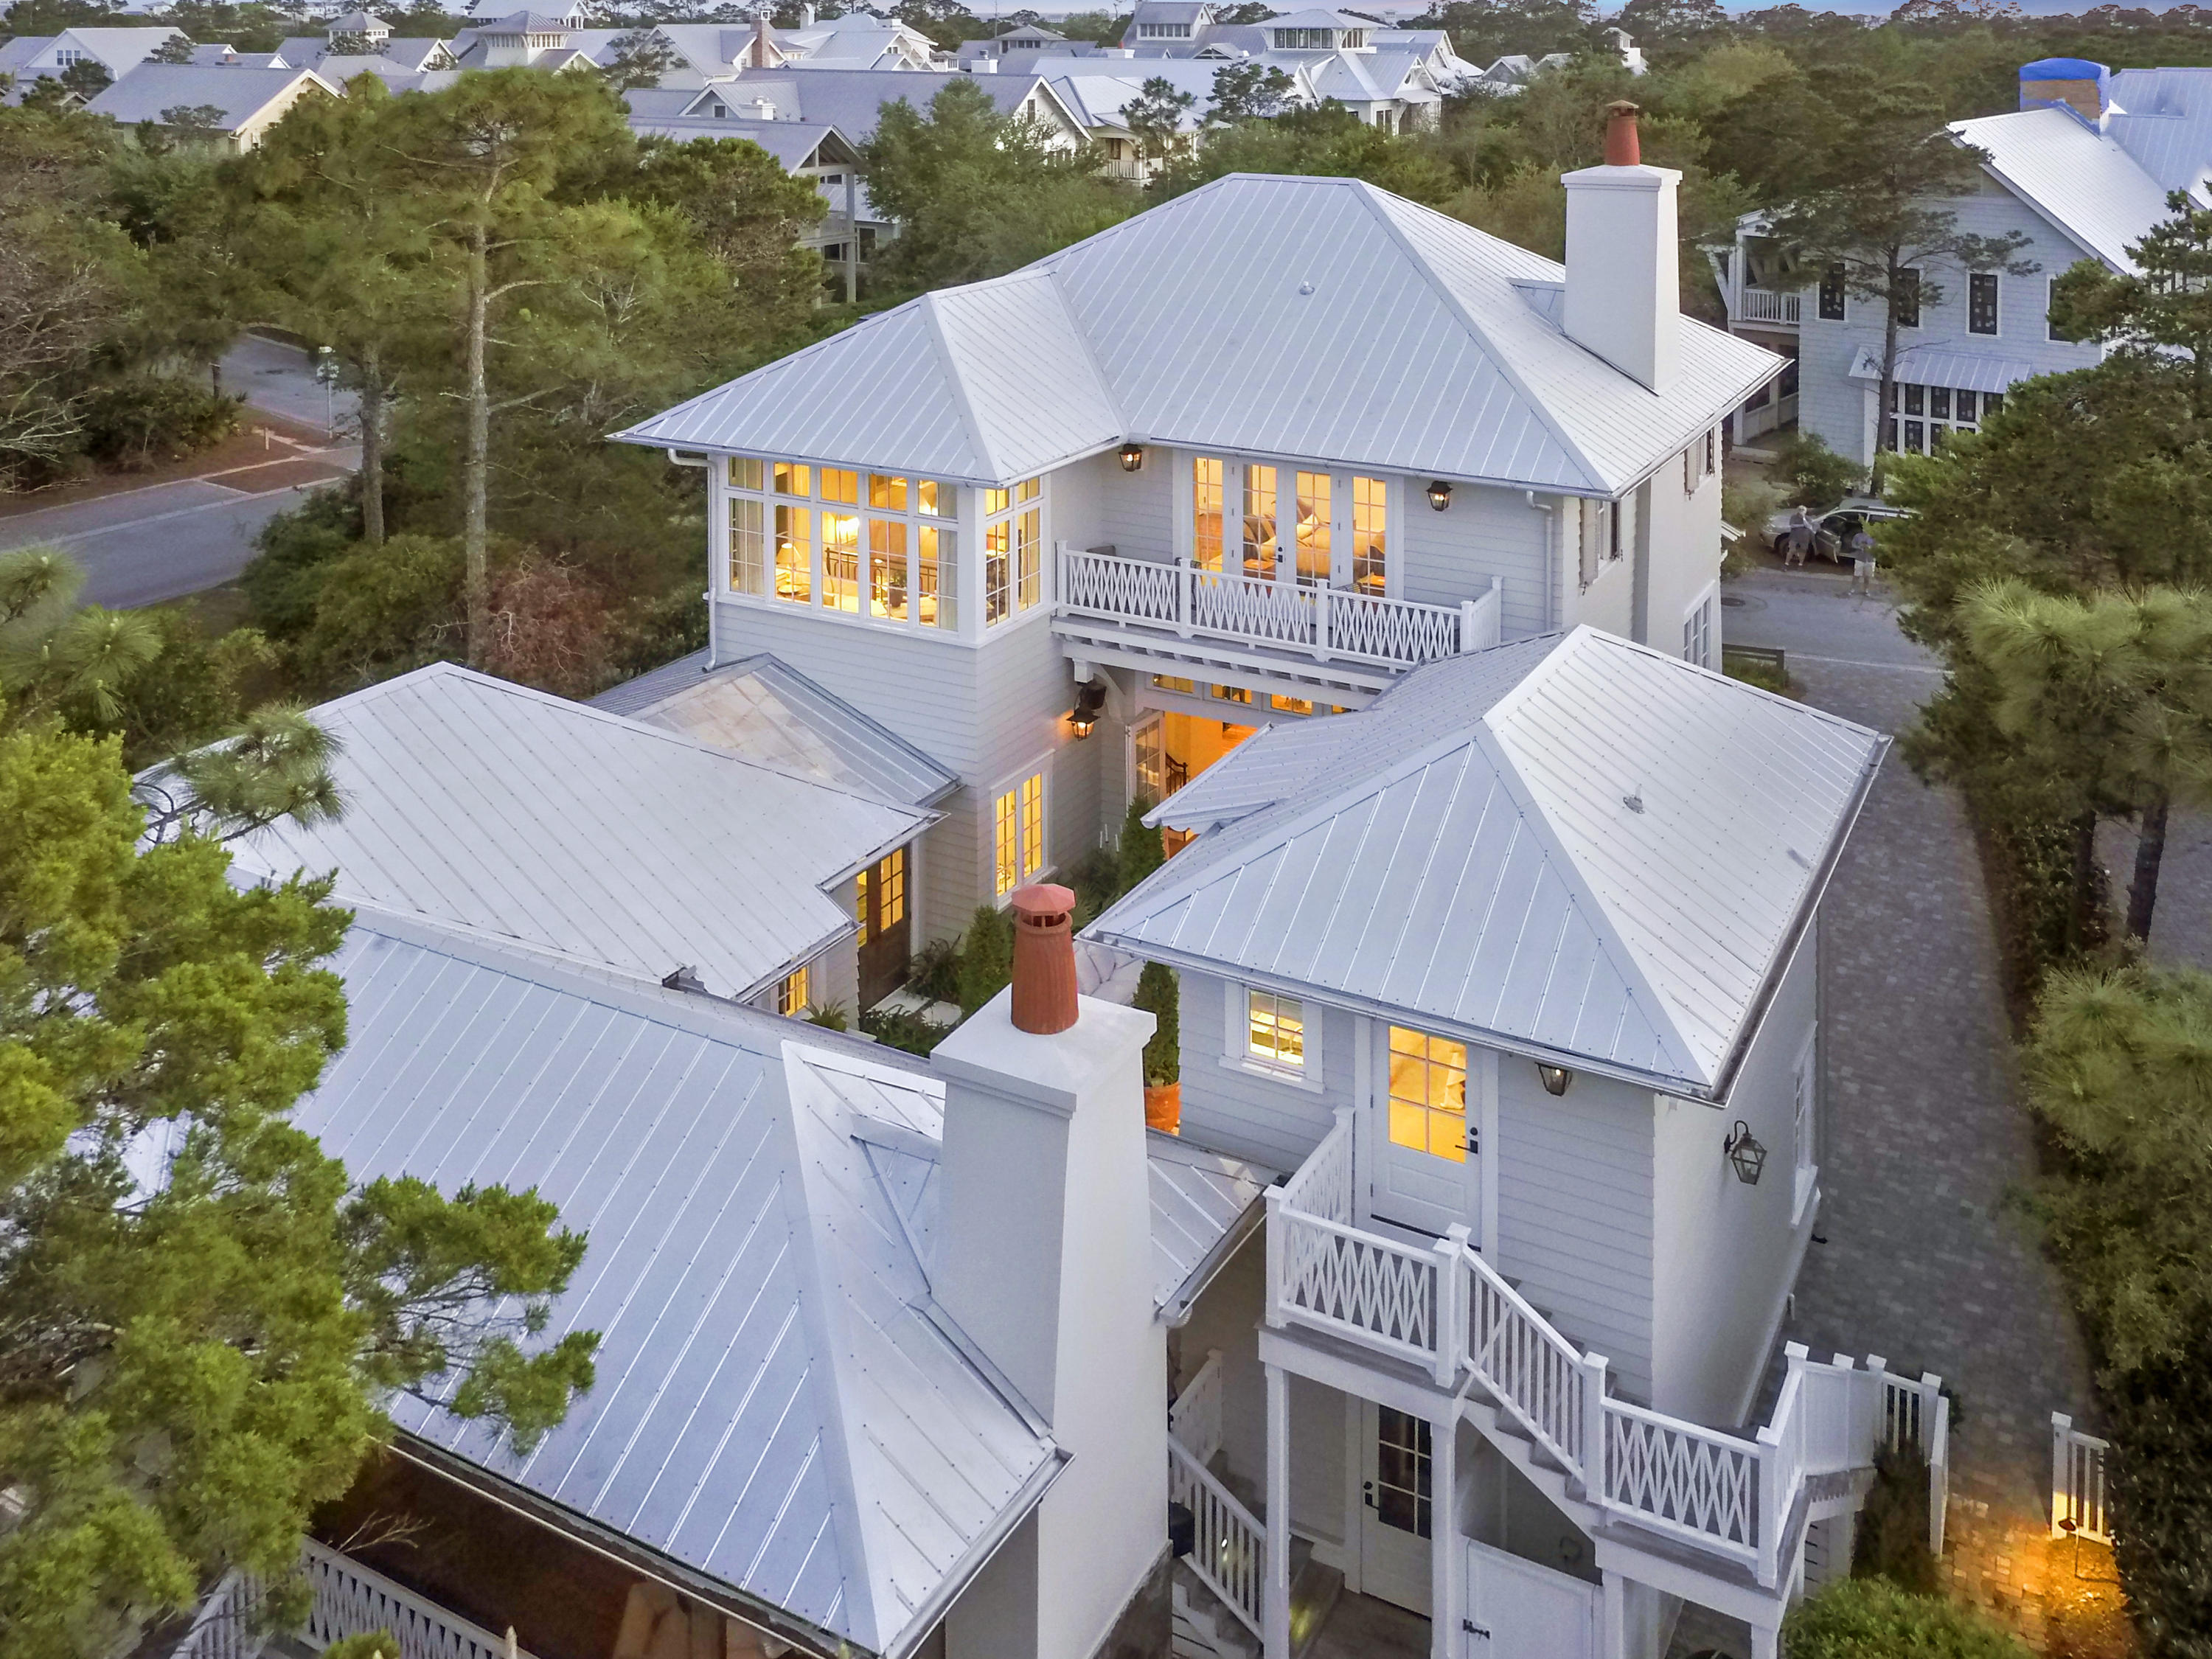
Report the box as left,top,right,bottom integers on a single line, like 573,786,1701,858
1084,626,1893,1659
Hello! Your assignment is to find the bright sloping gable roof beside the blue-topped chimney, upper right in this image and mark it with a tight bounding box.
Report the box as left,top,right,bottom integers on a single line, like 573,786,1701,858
1951,104,2166,272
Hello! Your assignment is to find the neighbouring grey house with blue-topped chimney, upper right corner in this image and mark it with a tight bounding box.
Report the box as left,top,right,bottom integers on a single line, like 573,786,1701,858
1714,58,2212,462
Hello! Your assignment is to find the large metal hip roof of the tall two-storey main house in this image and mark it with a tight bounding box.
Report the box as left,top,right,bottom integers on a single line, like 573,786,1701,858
615,178,1781,498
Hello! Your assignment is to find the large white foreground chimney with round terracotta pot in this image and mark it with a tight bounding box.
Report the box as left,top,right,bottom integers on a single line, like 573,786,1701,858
931,885,1168,1659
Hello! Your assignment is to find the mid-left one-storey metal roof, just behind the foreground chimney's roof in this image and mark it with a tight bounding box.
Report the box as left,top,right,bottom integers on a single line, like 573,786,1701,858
232,664,936,998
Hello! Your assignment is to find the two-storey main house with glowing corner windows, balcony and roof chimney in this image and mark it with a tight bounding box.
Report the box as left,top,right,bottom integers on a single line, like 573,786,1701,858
619,130,1781,969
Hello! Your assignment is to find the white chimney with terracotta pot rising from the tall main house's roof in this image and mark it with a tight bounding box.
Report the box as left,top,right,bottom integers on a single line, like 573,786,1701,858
1559,102,1681,392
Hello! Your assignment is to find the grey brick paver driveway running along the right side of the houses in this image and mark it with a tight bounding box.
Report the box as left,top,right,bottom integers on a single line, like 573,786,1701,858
1728,575,2090,1639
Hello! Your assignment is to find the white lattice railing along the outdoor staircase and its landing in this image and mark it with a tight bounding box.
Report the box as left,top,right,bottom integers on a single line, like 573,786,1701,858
1267,1110,1949,1586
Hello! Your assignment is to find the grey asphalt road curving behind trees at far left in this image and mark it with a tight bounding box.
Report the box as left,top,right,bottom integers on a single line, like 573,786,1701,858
0,334,361,608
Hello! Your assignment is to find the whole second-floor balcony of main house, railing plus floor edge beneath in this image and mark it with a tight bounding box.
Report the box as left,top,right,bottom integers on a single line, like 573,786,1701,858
1055,542,1502,692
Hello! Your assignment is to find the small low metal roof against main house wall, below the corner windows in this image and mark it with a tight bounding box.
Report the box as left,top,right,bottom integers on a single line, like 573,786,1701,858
591,650,960,807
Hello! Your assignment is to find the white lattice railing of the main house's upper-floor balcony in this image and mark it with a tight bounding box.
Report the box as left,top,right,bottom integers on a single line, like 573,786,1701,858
1057,542,1502,668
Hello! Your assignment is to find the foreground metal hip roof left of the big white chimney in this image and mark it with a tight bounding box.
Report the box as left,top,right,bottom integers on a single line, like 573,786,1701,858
294,914,1064,1652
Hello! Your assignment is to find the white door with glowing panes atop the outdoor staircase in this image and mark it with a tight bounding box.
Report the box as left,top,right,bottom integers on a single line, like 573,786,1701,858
1367,1022,1498,1248
